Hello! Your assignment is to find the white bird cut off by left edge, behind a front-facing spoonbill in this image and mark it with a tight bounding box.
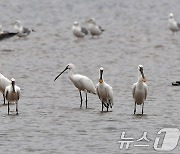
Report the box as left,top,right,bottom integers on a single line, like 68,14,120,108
0,73,11,104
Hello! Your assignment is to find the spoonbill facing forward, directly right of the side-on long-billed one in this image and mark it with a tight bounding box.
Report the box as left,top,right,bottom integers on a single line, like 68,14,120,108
96,67,113,111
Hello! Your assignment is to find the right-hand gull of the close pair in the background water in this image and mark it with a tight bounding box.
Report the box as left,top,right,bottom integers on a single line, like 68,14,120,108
86,18,104,37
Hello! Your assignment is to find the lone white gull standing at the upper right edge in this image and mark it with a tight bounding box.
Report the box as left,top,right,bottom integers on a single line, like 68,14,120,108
169,13,180,35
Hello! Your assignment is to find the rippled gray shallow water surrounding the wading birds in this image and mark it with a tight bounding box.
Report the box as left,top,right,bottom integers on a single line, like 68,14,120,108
0,0,180,154
